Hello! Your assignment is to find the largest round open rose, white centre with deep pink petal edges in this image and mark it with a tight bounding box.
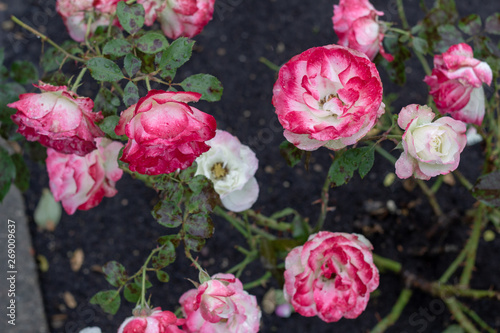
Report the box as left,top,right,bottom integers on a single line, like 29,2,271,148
273,45,385,150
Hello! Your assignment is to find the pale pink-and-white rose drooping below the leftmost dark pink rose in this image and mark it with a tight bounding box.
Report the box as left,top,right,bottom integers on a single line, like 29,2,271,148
46,138,123,215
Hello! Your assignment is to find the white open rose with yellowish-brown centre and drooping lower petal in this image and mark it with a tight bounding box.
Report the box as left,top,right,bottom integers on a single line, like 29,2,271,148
195,130,259,212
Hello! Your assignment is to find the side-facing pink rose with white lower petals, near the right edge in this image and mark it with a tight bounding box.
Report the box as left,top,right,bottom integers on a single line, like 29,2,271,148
424,43,493,125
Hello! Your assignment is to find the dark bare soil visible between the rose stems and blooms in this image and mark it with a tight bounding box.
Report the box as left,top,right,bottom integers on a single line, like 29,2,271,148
0,0,500,333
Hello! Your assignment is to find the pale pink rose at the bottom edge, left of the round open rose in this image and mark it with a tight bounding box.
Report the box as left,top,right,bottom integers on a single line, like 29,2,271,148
179,273,262,333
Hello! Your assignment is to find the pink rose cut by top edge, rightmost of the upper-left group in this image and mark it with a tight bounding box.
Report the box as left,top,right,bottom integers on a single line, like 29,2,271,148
158,0,215,39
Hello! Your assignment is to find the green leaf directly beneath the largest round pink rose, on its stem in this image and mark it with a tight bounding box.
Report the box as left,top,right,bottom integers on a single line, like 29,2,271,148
328,147,374,186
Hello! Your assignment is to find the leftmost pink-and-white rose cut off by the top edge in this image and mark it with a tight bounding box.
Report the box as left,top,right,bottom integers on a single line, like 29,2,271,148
56,0,121,42
